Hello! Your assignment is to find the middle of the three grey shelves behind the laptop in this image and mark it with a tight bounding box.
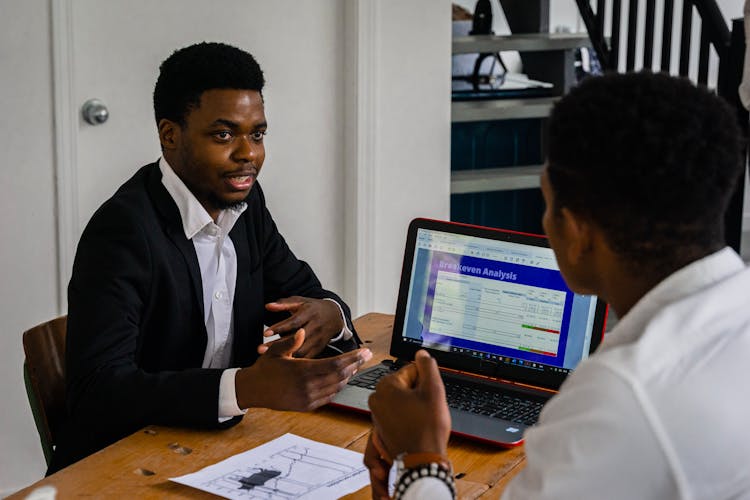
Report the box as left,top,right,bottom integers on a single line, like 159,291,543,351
451,97,559,123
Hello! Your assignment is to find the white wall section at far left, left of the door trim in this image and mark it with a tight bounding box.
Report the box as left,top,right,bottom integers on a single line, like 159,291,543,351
0,0,57,488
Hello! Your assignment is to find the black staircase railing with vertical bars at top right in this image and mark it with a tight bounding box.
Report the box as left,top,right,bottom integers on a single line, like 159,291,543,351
576,0,748,252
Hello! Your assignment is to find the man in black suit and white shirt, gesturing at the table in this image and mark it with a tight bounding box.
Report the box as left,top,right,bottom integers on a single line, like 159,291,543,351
48,43,371,472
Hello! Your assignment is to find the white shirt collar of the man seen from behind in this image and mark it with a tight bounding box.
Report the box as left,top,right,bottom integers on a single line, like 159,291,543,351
602,247,745,348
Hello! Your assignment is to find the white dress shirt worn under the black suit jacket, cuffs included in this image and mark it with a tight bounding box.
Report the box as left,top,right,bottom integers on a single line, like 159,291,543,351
159,157,352,421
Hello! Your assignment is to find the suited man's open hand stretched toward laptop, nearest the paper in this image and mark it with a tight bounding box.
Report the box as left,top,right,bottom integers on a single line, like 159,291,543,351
235,328,372,411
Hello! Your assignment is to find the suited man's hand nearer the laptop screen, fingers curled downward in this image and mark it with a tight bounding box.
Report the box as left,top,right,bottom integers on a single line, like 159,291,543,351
258,296,344,358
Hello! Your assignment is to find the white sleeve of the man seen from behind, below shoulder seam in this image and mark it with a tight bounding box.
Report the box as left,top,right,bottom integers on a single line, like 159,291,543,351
502,360,681,500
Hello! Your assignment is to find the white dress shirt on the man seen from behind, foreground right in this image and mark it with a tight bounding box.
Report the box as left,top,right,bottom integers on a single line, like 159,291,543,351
405,248,750,500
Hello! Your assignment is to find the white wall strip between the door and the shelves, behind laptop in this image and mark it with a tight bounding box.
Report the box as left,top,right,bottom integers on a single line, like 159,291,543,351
344,0,451,315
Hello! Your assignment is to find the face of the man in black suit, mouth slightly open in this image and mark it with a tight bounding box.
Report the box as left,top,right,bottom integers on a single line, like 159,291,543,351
166,89,267,219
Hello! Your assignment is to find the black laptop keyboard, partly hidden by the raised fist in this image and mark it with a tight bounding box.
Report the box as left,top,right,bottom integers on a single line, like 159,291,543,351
349,365,545,425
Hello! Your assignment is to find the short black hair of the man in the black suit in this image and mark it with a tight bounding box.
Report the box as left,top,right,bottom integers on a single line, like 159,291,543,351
154,42,265,125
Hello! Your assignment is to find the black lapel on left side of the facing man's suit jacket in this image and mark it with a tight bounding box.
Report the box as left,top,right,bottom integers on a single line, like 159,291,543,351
147,163,206,320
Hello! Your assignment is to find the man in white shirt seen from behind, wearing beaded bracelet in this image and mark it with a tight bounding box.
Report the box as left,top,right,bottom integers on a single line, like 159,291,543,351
365,73,750,500
